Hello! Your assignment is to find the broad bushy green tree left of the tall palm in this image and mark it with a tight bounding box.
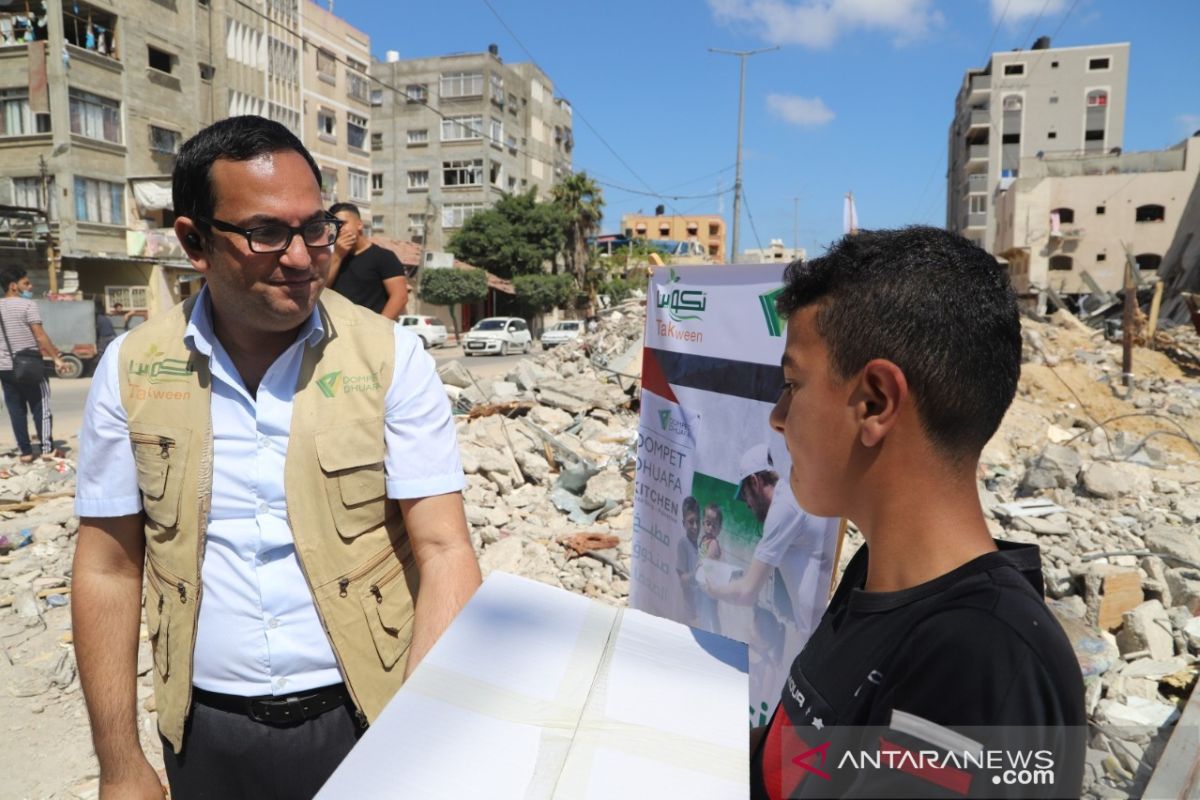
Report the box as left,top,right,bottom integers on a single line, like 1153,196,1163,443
449,190,566,278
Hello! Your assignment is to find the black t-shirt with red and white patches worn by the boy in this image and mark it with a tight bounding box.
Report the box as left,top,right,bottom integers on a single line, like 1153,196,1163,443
751,542,1087,800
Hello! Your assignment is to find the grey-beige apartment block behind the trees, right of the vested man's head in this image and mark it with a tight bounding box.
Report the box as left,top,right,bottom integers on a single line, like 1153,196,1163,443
371,46,574,252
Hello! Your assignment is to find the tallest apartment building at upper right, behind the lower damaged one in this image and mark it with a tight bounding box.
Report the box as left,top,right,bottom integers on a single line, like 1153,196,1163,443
946,37,1129,251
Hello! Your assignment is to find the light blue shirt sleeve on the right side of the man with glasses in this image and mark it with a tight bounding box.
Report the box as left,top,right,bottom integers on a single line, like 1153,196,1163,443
384,325,467,500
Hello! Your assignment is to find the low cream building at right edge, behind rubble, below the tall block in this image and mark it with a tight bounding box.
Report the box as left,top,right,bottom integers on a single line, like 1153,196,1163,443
995,137,1200,294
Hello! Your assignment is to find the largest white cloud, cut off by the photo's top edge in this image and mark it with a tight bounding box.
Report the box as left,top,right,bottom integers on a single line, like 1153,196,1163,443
708,0,940,49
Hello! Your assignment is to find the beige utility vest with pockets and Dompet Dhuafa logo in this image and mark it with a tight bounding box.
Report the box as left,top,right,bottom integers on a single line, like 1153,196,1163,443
118,291,418,752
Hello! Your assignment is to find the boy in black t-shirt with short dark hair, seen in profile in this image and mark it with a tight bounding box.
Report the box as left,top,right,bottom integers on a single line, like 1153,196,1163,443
751,227,1086,800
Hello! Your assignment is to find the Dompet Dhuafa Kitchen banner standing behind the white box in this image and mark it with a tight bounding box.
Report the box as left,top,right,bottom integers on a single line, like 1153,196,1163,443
631,265,839,726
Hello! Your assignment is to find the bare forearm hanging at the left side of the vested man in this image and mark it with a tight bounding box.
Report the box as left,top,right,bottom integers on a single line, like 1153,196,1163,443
71,525,145,782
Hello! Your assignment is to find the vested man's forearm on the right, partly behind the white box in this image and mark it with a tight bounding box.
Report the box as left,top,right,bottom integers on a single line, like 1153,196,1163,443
404,542,480,678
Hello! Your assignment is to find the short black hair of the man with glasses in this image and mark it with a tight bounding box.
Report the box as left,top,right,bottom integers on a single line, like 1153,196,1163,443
170,116,320,225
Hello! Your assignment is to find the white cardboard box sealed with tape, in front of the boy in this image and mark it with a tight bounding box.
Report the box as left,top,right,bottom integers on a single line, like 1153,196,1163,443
318,572,749,800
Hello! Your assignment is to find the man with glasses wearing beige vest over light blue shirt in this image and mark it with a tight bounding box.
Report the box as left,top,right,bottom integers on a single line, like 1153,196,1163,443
73,116,480,800
